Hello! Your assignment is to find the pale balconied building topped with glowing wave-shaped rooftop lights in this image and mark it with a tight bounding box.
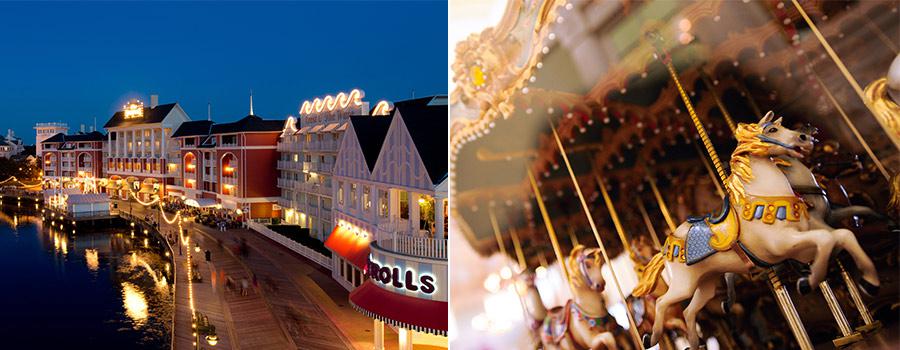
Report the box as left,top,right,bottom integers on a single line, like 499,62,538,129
277,89,389,241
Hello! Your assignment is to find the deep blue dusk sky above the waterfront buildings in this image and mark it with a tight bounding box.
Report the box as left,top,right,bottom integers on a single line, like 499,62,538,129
0,2,448,144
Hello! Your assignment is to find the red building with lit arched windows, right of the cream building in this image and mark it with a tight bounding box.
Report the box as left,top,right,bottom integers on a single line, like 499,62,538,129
169,105,284,219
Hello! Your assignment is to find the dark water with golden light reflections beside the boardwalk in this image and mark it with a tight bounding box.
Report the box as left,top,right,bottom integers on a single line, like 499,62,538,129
0,208,174,349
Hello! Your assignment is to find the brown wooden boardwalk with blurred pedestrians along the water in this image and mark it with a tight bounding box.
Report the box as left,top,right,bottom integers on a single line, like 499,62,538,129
118,205,380,350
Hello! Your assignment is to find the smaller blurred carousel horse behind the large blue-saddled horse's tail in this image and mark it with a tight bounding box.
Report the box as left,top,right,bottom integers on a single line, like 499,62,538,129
530,245,632,350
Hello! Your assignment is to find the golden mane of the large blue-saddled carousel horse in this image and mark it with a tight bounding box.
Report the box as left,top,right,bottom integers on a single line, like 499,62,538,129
725,123,770,203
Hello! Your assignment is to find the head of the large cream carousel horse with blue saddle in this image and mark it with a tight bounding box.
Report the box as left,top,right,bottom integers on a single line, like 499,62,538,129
752,111,816,158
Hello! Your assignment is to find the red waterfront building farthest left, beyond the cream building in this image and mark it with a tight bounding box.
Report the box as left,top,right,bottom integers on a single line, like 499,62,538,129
39,131,107,181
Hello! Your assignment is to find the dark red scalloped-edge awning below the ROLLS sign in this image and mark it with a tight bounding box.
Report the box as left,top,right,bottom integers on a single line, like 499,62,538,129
350,280,447,336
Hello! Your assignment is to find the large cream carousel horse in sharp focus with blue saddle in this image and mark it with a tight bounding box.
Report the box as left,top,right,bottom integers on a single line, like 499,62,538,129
632,111,852,349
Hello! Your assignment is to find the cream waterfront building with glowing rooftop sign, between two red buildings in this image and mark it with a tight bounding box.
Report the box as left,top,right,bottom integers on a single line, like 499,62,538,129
104,95,190,198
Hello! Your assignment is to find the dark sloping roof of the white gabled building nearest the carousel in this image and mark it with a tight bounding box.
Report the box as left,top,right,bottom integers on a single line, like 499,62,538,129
394,95,448,185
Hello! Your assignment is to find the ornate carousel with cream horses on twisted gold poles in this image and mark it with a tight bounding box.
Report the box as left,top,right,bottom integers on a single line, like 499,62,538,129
450,0,900,349
